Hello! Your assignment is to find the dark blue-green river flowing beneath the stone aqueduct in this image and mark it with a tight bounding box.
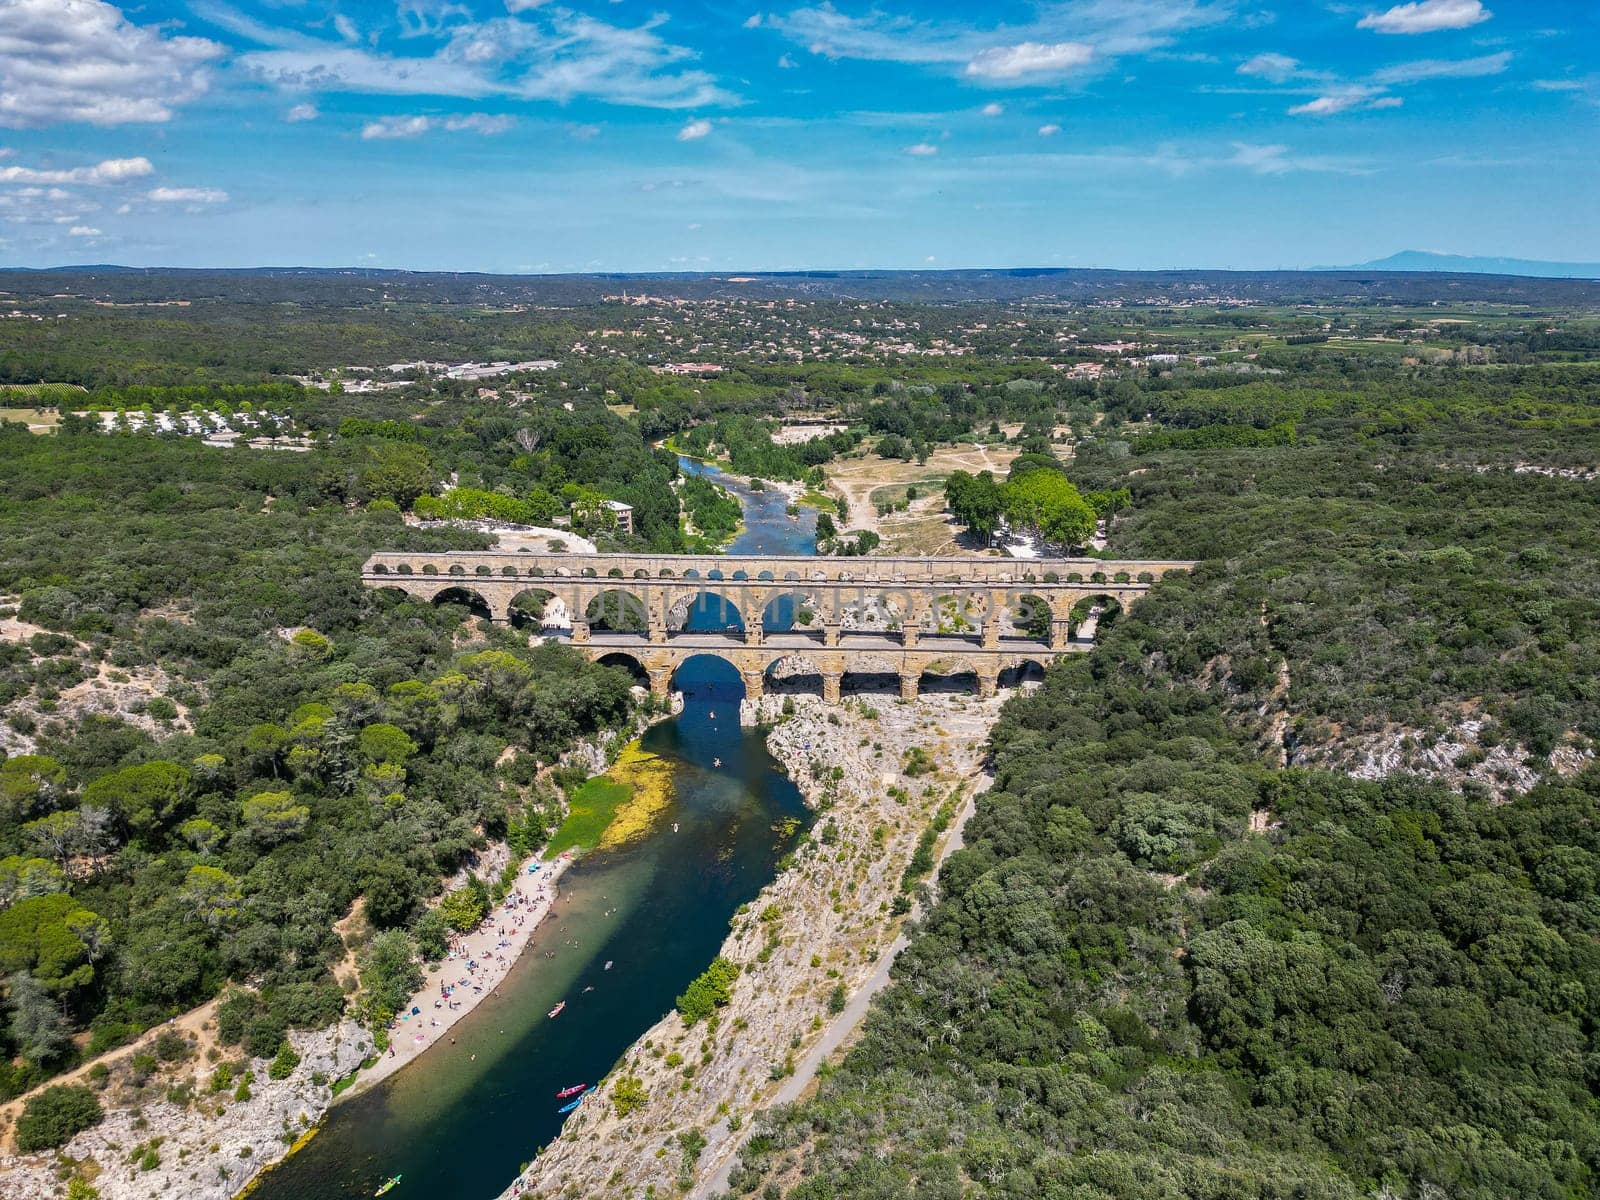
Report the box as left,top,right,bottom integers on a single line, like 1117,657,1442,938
251,459,814,1200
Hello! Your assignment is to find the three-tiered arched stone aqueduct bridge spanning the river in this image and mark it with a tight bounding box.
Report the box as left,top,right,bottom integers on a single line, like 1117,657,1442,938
362,552,1194,701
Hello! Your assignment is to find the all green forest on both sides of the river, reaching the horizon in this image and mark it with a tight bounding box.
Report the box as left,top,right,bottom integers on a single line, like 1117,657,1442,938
0,284,1600,1200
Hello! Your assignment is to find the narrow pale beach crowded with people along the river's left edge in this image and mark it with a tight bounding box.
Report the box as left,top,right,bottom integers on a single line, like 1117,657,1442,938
344,851,573,1096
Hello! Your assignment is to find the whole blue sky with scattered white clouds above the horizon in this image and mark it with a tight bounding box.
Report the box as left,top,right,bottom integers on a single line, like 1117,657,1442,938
0,0,1600,272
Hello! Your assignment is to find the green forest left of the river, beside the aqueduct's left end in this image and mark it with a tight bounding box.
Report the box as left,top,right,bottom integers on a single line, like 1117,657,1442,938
0,424,636,1094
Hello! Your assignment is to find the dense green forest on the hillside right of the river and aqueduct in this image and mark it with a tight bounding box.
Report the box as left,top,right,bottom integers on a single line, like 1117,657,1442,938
733,350,1600,1200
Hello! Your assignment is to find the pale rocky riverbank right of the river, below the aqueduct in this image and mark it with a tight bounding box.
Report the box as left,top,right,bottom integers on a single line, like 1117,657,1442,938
506,696,1003,1197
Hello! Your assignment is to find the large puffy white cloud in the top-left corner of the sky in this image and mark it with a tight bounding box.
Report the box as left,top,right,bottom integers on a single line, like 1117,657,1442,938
0,0,224,128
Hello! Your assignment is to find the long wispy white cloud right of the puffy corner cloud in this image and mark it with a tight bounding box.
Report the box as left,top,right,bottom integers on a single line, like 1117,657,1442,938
238,8,736,109
